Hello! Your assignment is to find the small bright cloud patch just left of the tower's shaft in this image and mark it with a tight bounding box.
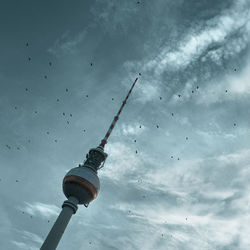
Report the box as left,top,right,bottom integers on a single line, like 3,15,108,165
20,202,61,218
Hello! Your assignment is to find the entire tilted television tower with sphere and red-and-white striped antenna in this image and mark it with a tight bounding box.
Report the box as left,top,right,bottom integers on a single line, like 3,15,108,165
40,77,140,250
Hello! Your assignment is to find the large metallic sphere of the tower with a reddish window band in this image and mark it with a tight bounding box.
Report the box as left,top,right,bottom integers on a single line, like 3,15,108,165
63,166,100,205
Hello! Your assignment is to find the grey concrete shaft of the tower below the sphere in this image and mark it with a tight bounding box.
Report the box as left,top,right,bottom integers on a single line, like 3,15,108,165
40,196,79,250
